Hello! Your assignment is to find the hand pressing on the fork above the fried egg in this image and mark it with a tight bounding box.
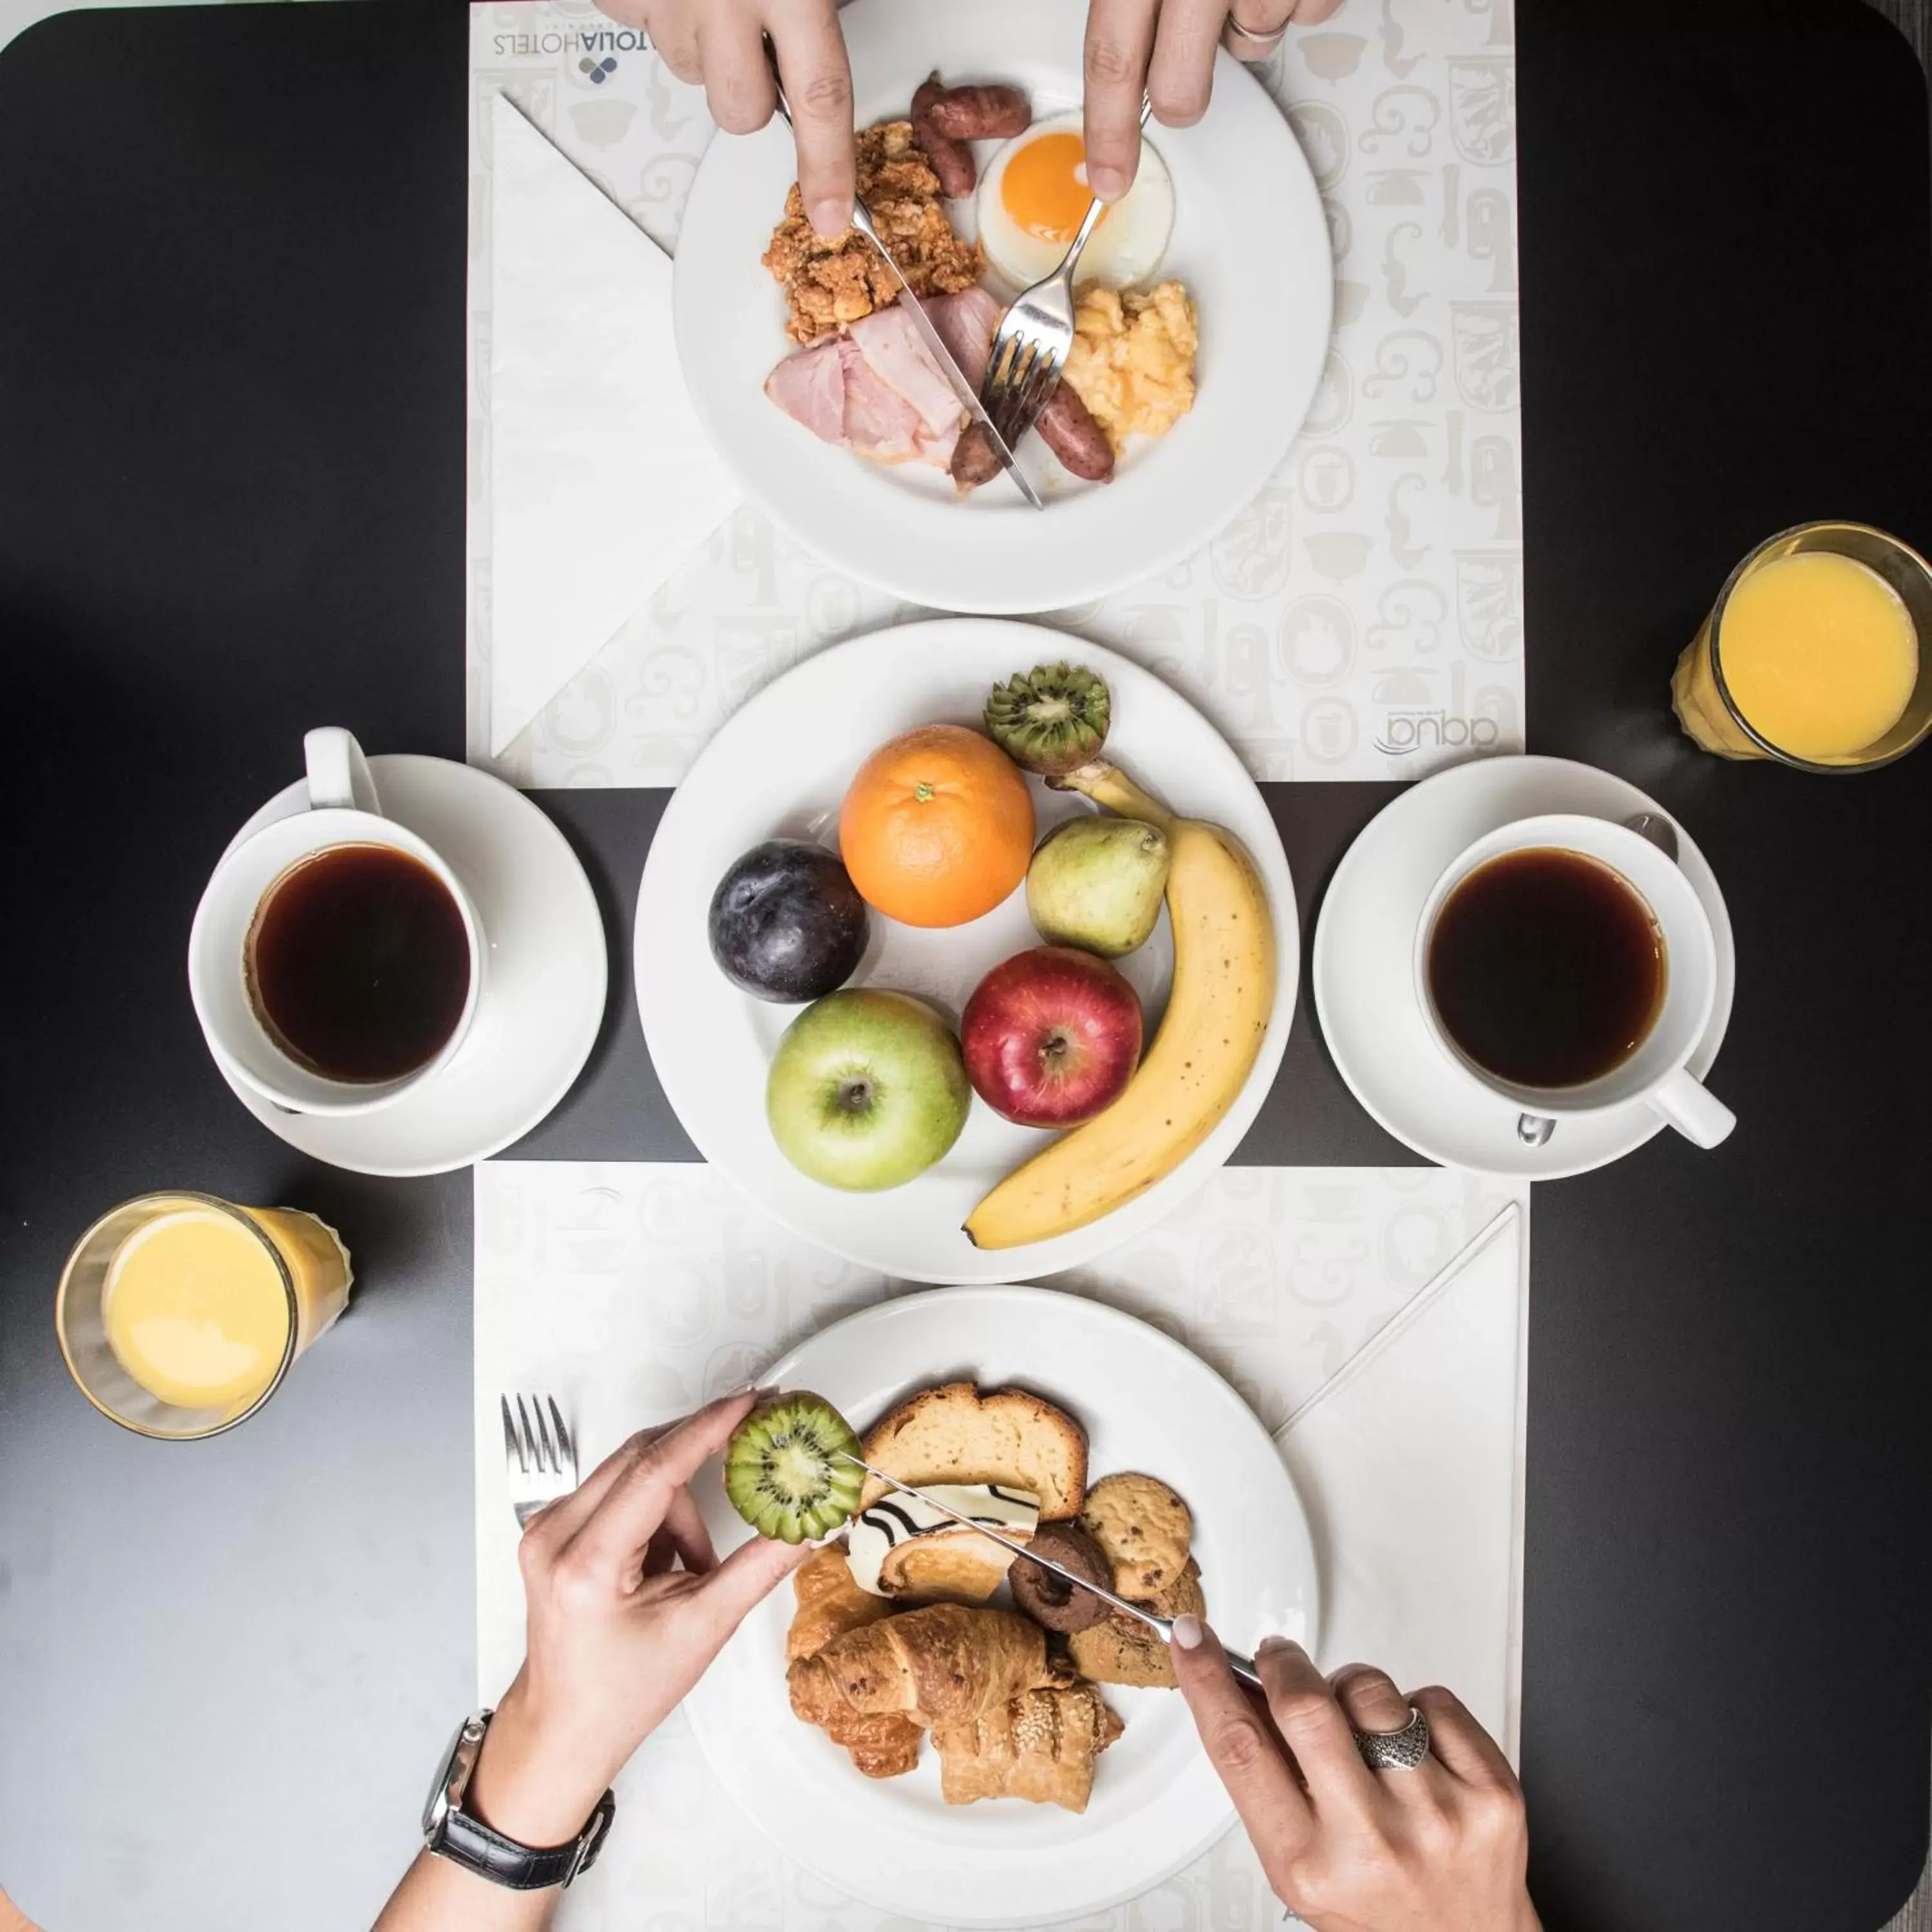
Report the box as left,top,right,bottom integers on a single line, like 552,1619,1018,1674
1086,0,1341,201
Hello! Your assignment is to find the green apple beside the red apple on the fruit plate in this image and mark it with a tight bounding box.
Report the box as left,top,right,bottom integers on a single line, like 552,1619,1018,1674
765,987,972,1194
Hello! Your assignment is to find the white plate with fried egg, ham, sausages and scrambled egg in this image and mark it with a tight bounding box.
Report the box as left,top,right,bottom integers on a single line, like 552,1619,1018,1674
674,0,1333,612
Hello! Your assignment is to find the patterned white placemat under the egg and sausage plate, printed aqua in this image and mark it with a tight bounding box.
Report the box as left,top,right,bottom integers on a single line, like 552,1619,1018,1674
469,0,1522,784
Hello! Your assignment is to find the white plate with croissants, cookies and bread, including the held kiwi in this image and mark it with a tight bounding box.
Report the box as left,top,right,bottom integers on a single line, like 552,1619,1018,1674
686,1287,1318,1926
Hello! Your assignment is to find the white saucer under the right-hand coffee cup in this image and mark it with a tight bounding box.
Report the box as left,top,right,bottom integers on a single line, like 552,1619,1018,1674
1312,757,1737,1180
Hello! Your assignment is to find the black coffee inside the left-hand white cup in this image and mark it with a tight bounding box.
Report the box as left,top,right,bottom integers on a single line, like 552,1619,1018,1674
245,844,469,1084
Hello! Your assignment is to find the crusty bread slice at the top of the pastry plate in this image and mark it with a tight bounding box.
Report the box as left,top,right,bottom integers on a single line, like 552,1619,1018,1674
860,1381,1086,1522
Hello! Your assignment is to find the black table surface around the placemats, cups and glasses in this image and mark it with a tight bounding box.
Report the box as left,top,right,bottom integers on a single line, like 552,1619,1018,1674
0,0,1932,1932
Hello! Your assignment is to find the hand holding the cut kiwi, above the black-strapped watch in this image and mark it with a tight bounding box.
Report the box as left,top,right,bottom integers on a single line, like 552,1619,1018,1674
468,1391,810,1845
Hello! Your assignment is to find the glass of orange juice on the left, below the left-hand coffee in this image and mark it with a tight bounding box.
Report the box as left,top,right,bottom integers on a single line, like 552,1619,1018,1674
54,1190,354,1441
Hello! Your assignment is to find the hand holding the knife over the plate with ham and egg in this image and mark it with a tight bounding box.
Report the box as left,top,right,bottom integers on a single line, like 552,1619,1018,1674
597,0,854,236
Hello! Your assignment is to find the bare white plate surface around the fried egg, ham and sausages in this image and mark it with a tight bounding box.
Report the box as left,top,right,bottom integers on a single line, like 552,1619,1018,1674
672,0,1335,612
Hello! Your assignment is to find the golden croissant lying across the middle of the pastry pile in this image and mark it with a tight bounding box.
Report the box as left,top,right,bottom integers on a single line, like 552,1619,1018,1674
786,1604,1072,1735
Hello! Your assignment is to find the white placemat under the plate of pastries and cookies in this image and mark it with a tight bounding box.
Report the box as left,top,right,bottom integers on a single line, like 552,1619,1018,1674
475,1161,1528,1932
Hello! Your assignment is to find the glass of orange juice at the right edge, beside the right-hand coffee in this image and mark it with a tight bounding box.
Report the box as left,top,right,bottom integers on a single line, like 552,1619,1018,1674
1671,524,1932,771
